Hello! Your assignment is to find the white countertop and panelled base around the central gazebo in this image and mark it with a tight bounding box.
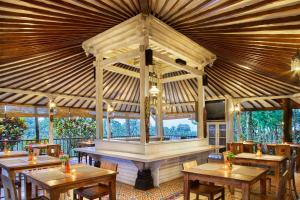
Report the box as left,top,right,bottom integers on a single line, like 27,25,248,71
76,146,221,187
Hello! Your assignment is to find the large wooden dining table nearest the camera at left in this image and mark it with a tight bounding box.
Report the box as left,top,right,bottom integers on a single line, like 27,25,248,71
22,164,117,200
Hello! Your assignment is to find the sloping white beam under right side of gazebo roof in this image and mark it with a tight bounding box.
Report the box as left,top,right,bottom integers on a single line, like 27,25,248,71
153,51,203,76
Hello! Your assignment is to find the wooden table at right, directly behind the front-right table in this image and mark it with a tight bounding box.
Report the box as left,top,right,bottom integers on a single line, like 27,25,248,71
233,153,288,193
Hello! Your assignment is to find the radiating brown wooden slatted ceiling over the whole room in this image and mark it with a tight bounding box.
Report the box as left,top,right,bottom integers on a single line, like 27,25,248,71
0,0,300,112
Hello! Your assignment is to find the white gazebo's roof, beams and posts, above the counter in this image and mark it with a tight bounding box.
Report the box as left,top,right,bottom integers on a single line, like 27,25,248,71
82,14,216,143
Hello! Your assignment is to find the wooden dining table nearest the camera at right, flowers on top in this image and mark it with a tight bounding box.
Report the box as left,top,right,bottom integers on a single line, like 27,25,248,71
183,163,268,200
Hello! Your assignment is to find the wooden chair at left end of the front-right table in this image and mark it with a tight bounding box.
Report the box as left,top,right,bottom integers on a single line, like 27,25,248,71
183,160,225,200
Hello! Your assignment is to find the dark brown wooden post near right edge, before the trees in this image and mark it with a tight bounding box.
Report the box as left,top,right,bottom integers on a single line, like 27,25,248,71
283,99,293,142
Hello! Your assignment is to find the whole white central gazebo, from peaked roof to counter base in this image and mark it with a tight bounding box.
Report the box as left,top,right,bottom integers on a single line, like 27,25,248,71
82,14,218,187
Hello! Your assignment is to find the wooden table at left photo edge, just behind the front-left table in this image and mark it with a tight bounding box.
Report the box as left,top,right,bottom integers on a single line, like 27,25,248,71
0,155,61,180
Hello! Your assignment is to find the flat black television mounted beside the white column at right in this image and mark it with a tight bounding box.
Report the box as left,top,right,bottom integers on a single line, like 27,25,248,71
205,100,225,121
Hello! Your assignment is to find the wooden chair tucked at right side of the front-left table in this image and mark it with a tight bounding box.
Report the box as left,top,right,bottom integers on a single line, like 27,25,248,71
73,161,118,200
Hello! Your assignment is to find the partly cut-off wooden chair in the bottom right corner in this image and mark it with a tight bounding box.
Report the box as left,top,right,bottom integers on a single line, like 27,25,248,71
250,170,291,200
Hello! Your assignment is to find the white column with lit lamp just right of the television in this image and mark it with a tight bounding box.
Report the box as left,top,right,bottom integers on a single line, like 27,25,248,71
225,96,234,143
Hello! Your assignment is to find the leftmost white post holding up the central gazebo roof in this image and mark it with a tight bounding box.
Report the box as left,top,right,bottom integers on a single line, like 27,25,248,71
95,56,104,140
